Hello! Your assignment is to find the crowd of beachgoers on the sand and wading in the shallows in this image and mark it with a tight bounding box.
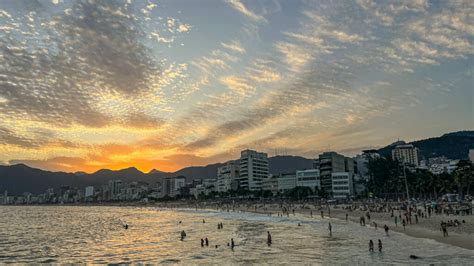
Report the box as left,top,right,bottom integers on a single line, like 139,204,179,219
128,201,472,259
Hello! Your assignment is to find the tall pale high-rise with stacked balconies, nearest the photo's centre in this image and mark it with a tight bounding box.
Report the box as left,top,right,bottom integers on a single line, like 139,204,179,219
239,150,269,191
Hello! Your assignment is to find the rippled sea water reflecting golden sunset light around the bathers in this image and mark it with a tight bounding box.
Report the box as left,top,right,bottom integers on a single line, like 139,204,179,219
0,206,474,265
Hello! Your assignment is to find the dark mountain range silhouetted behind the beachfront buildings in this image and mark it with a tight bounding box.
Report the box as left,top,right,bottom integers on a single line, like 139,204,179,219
0,131,474,194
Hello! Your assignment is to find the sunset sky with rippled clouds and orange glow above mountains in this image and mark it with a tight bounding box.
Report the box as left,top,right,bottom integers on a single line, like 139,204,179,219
0,0,474,172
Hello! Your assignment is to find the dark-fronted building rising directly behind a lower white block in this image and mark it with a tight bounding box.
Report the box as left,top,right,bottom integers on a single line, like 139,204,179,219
315,152,354,193
